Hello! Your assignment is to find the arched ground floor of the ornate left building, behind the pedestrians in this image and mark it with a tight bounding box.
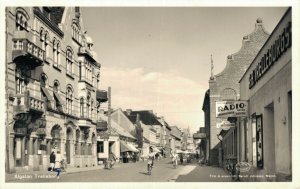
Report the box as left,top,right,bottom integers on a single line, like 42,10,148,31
6,113,97,172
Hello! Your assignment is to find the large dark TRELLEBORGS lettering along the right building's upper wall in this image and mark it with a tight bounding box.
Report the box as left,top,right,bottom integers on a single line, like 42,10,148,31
249,22,292,89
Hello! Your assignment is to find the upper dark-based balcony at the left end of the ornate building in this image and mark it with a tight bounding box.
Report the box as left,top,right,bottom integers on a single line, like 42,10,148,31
12,31,45,67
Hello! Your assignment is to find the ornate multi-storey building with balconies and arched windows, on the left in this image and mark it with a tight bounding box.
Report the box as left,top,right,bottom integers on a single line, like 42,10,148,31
5,7,107,172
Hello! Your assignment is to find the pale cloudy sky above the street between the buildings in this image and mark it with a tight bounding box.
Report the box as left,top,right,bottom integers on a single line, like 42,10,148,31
82,7,287,132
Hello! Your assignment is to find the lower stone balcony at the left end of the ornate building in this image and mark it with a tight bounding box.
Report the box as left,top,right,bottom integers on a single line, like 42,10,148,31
12,91,45,114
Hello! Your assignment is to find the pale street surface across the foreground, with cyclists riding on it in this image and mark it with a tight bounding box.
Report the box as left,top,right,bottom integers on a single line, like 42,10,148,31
8,158,230,182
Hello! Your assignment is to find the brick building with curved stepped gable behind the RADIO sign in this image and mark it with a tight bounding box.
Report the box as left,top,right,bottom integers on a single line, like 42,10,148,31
202,19,269,165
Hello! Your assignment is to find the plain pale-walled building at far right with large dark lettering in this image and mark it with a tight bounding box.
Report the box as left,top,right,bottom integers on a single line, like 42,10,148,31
237,8,292,181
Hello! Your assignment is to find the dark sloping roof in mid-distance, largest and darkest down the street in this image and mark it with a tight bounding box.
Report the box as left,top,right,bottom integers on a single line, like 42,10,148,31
124,110,162,126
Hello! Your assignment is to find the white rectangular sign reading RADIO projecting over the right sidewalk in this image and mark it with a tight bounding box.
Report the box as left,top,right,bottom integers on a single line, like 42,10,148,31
216,101,248,117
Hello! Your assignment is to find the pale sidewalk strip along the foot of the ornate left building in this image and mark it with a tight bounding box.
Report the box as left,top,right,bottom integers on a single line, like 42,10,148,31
5,163,105,182
